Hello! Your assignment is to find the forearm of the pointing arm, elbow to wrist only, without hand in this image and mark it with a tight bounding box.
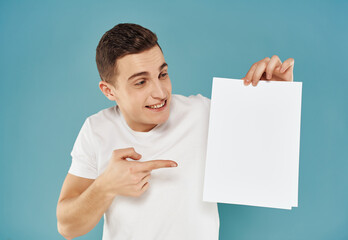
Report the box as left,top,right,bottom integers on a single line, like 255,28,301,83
57,177,115,239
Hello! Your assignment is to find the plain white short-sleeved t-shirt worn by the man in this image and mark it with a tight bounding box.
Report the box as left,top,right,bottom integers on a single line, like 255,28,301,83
69,94,220,240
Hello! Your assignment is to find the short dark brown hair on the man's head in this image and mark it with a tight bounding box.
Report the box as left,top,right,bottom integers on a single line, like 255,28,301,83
96,23,162,83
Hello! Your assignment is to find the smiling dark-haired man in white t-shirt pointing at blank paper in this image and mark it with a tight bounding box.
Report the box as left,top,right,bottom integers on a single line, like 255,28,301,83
57,24,294,240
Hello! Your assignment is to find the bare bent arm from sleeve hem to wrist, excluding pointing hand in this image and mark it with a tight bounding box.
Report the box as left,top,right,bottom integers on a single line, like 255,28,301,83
57,174,115,239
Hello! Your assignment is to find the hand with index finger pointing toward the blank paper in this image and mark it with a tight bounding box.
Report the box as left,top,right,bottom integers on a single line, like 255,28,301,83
101,148,178,197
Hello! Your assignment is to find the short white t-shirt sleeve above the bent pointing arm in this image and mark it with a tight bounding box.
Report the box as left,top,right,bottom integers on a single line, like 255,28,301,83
69,118,98,179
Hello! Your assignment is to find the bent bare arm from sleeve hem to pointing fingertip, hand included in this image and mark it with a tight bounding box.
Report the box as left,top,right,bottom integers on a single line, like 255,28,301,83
57,148,177,239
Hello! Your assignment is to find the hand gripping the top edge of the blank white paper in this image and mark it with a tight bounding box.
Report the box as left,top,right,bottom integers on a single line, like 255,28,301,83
242,55,295,86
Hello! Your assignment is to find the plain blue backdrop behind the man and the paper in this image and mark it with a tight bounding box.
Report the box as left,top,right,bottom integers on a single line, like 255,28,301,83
0,1,348,240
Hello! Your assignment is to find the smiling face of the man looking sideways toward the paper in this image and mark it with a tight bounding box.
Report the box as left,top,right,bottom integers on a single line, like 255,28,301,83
106,45,172,132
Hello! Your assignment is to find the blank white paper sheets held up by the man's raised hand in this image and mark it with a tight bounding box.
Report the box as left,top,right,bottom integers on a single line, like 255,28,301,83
203,78,302,209
